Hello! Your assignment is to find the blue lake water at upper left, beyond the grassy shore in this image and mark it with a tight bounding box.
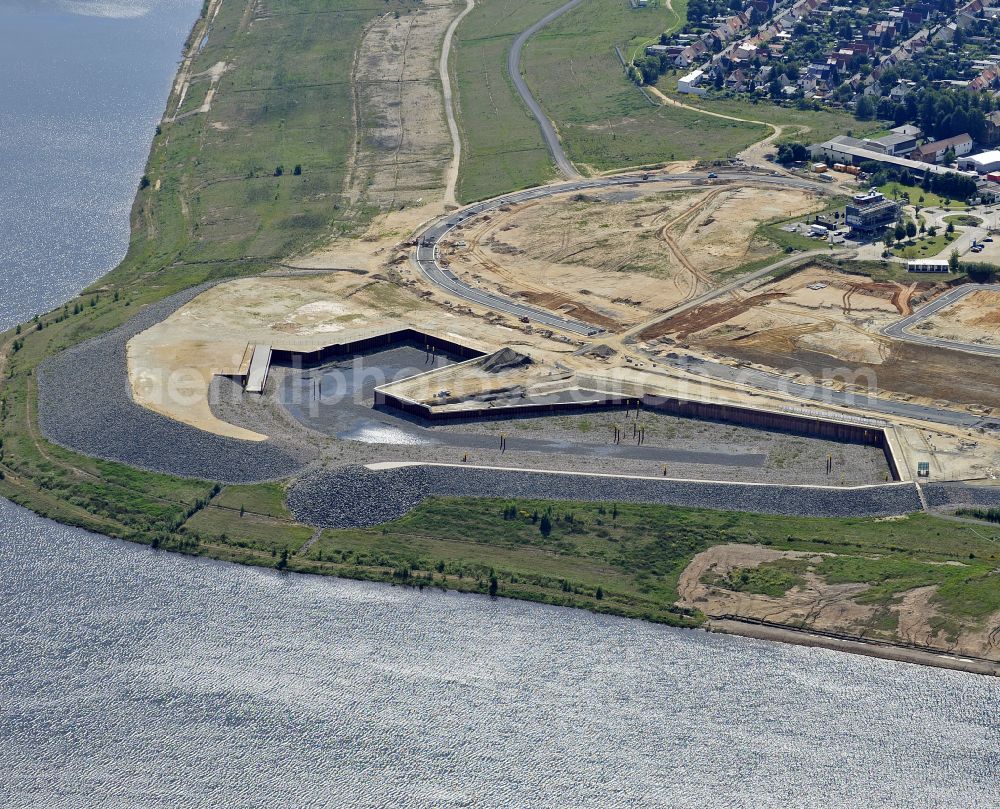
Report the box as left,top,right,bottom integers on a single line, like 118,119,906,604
0,0,201,330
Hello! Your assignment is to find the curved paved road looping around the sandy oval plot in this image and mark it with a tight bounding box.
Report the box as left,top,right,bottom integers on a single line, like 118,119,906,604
414,170,834,337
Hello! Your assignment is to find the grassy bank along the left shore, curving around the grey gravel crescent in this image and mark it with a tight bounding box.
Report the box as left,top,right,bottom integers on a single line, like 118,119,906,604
0,0,398,547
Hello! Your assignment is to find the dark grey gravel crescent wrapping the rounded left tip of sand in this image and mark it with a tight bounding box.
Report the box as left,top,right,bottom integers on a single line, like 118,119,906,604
38,284,310,483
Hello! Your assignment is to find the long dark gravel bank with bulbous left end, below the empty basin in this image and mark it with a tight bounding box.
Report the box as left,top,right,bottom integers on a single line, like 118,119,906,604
288,466,921,528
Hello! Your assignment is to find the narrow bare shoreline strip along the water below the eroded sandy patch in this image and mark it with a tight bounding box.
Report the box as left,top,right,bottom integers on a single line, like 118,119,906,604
702,616,1000,677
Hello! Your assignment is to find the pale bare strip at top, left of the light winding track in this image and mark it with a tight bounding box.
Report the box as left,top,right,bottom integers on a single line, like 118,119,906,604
347,2,458,209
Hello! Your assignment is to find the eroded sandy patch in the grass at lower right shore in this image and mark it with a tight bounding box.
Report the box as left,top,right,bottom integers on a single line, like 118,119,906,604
678,544,1000,661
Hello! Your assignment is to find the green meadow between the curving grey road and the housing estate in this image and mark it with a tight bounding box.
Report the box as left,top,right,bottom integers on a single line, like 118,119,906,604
523,0,767,172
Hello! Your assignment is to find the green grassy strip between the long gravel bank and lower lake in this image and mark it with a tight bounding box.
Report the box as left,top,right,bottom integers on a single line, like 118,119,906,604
188,486,1000,634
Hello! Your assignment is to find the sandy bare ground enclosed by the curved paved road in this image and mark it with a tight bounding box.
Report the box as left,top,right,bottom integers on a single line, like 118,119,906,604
438,186,819,330
